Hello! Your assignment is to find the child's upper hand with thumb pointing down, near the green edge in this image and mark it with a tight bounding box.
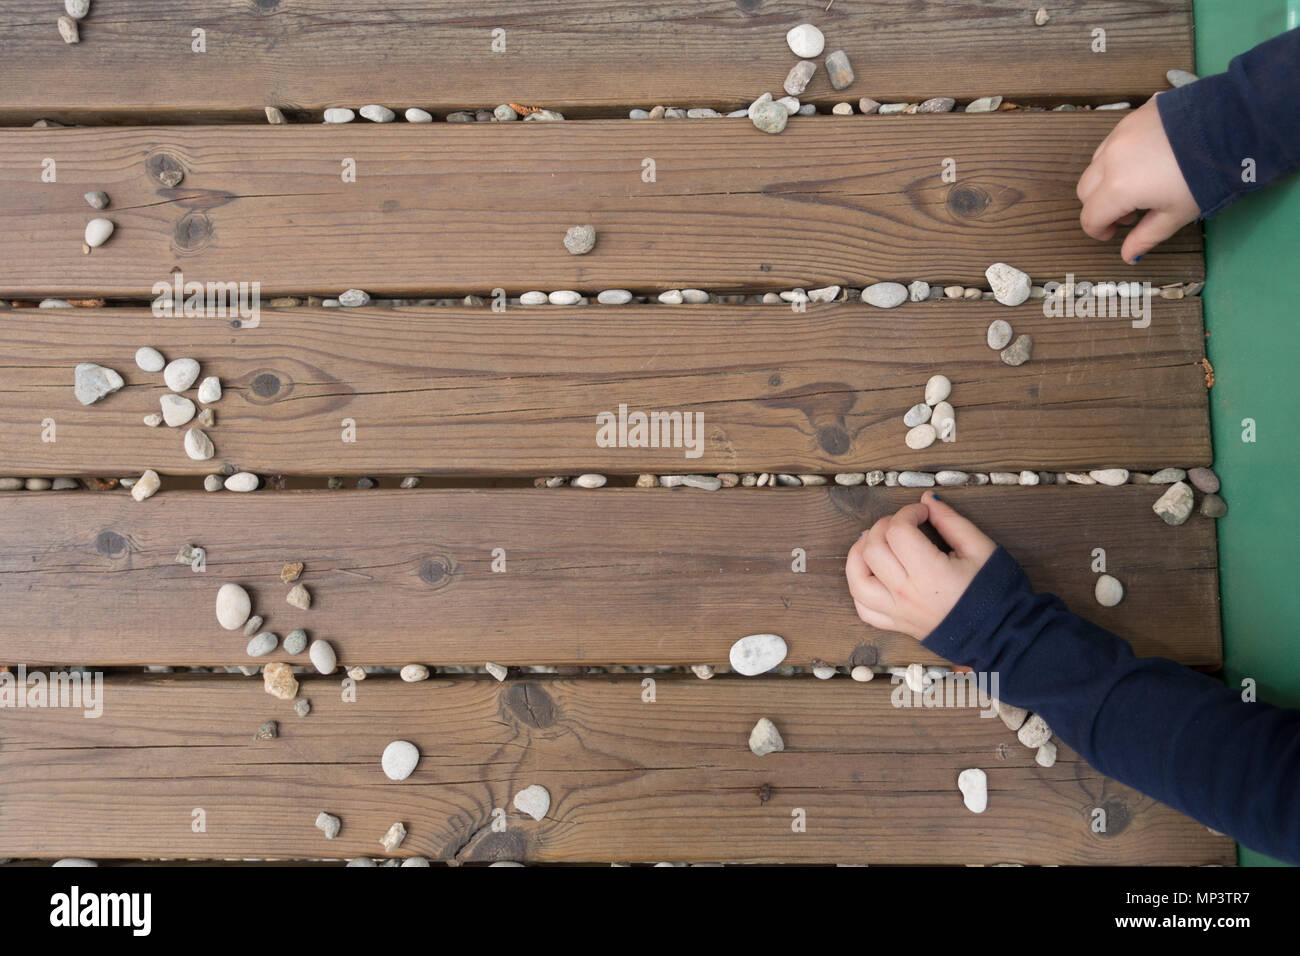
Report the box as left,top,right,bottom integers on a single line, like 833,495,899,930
1075,96,1201,263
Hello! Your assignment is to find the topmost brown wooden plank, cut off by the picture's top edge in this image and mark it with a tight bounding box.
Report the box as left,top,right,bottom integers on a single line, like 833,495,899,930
0,0,1192,122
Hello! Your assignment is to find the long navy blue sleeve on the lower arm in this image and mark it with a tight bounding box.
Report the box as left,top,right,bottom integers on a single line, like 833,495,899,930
922,548,1300,864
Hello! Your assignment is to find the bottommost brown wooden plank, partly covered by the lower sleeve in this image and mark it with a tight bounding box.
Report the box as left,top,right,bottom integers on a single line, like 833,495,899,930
0,676,1234,865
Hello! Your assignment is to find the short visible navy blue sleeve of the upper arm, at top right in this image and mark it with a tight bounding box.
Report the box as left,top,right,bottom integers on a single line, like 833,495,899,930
1156,27,1300,217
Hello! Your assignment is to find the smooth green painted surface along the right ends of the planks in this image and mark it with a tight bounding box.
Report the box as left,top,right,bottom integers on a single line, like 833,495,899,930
1195,0,1300,866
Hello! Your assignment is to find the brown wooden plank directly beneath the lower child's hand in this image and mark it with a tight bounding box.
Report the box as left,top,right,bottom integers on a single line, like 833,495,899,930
0,485,1221,666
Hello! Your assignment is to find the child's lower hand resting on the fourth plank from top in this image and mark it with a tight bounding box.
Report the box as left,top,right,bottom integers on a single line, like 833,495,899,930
845,492,997,640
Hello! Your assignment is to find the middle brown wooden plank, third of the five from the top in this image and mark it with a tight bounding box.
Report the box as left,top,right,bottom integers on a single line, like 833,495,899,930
0,298,1212,476
